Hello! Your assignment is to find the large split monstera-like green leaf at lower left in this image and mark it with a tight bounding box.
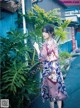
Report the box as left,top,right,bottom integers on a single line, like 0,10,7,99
2,61,26,93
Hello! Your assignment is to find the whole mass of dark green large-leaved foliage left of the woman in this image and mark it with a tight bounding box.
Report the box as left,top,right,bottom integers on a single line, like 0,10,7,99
0,31,39,108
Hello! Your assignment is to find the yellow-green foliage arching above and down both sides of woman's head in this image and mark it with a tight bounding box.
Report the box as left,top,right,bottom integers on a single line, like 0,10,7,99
18,5,70,41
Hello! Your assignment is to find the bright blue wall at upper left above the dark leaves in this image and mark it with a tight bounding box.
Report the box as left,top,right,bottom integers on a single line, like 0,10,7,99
0,12,17,37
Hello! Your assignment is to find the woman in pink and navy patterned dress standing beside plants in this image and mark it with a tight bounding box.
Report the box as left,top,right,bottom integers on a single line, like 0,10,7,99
34,24,67,108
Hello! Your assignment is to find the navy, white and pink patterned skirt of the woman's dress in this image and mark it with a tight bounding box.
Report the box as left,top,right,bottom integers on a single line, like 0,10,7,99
41,60,67,102
